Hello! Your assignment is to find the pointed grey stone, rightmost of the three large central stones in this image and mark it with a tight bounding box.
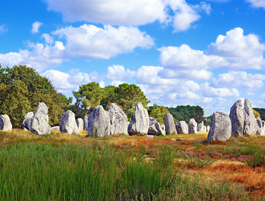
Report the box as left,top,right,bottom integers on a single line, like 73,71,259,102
128,103,149,135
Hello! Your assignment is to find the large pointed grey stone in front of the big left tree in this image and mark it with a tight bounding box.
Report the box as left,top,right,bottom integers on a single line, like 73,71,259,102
30,103,51,135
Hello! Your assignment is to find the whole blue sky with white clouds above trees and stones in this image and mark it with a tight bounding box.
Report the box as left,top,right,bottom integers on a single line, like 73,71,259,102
0,0,265,116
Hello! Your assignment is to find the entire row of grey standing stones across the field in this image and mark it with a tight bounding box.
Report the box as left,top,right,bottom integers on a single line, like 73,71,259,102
0,99,265,141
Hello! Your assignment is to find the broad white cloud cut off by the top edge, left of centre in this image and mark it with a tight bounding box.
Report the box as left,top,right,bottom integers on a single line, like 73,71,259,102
45,0,211,32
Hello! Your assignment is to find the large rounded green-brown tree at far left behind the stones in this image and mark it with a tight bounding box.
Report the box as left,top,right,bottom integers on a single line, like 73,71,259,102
0,65,67,127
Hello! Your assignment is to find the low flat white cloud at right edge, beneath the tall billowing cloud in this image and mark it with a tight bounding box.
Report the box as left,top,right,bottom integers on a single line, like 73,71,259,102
211,71,265,89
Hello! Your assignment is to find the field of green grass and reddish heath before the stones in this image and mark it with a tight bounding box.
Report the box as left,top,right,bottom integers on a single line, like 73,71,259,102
0,129,265,201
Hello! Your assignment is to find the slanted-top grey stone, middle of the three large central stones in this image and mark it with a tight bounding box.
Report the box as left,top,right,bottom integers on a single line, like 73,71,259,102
108,103,128,135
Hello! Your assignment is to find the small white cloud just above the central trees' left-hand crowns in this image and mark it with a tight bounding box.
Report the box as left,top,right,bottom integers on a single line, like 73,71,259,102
106,65,135,80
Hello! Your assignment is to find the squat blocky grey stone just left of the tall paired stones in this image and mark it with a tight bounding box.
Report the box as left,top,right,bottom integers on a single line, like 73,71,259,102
207,112,231,141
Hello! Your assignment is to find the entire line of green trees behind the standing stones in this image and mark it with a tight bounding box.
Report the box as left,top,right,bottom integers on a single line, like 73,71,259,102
0,65,236,128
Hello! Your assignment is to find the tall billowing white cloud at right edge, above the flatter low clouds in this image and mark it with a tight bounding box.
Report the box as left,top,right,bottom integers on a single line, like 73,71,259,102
208,28,265,69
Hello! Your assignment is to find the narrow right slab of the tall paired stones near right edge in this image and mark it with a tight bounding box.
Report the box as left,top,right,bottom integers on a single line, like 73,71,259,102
243,98,258,135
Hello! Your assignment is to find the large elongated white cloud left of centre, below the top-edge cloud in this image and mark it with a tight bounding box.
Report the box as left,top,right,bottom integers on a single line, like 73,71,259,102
53,24,154,59
